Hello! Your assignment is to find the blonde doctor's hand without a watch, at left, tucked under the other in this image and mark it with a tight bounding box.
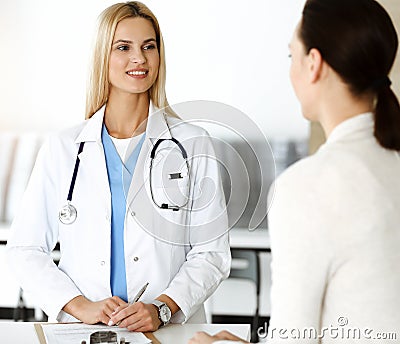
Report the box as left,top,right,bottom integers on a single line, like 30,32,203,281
63,295,127,325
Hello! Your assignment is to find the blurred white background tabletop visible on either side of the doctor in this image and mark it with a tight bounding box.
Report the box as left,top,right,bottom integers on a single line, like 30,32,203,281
0,224,271,251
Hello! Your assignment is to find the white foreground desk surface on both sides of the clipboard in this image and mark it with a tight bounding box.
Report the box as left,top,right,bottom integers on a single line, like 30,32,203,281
0,322,250,344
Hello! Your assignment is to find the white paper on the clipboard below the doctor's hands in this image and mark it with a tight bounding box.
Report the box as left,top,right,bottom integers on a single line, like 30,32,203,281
42,323,151,344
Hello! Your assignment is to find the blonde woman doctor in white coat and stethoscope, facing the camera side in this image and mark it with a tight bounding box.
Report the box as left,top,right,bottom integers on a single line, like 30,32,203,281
8,2,231,331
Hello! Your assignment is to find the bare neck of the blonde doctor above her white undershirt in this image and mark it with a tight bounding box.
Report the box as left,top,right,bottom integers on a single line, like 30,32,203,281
104,92,150,139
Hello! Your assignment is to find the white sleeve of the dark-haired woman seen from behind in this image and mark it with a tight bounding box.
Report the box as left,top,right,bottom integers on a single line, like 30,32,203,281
267,165,332,344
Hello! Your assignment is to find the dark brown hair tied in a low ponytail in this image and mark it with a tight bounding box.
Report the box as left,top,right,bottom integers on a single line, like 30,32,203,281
299,0,400,150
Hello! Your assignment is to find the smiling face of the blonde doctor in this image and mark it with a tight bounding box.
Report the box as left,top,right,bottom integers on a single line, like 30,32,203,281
109,17,160,94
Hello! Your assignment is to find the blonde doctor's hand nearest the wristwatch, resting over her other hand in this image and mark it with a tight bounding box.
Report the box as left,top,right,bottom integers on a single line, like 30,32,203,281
108,302,161,332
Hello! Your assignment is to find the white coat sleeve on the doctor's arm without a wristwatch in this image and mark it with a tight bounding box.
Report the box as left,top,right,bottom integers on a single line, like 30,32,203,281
7,139,81,318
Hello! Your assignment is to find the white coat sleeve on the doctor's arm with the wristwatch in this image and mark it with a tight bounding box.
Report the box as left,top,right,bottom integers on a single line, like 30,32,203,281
164,134,231,322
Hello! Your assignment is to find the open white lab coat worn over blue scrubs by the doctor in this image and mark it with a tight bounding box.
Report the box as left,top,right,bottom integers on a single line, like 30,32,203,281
7,108,231,322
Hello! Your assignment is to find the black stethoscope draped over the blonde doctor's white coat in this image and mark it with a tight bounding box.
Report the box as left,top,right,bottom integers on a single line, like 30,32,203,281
58,123,190,225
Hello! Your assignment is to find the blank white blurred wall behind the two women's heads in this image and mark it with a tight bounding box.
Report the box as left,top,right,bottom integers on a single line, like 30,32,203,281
0,0,308,139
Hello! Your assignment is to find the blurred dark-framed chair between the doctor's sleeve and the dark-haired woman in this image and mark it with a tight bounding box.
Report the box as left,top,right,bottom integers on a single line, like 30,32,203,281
229,249,260,343
